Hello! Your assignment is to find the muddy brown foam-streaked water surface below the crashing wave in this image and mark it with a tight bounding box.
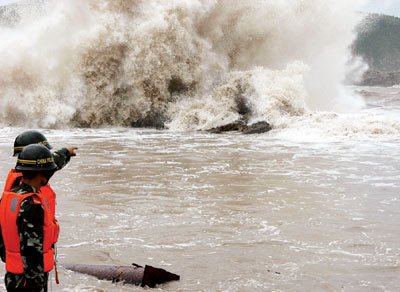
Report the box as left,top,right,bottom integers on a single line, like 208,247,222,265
0,89,400,291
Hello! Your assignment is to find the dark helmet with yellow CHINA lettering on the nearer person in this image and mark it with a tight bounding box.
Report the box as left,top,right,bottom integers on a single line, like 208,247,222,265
15,144,57,171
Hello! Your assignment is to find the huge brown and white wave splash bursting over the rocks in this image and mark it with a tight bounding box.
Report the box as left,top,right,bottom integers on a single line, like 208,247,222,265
0,0,396,136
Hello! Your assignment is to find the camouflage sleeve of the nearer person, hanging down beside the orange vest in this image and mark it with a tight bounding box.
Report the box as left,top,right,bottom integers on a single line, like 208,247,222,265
17,197,45,287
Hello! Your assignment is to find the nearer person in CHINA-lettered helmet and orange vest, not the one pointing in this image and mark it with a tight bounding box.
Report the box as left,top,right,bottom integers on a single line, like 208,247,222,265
0,144,59,292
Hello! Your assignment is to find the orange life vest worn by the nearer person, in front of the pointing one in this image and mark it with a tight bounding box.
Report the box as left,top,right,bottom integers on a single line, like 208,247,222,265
0,192,59,274
